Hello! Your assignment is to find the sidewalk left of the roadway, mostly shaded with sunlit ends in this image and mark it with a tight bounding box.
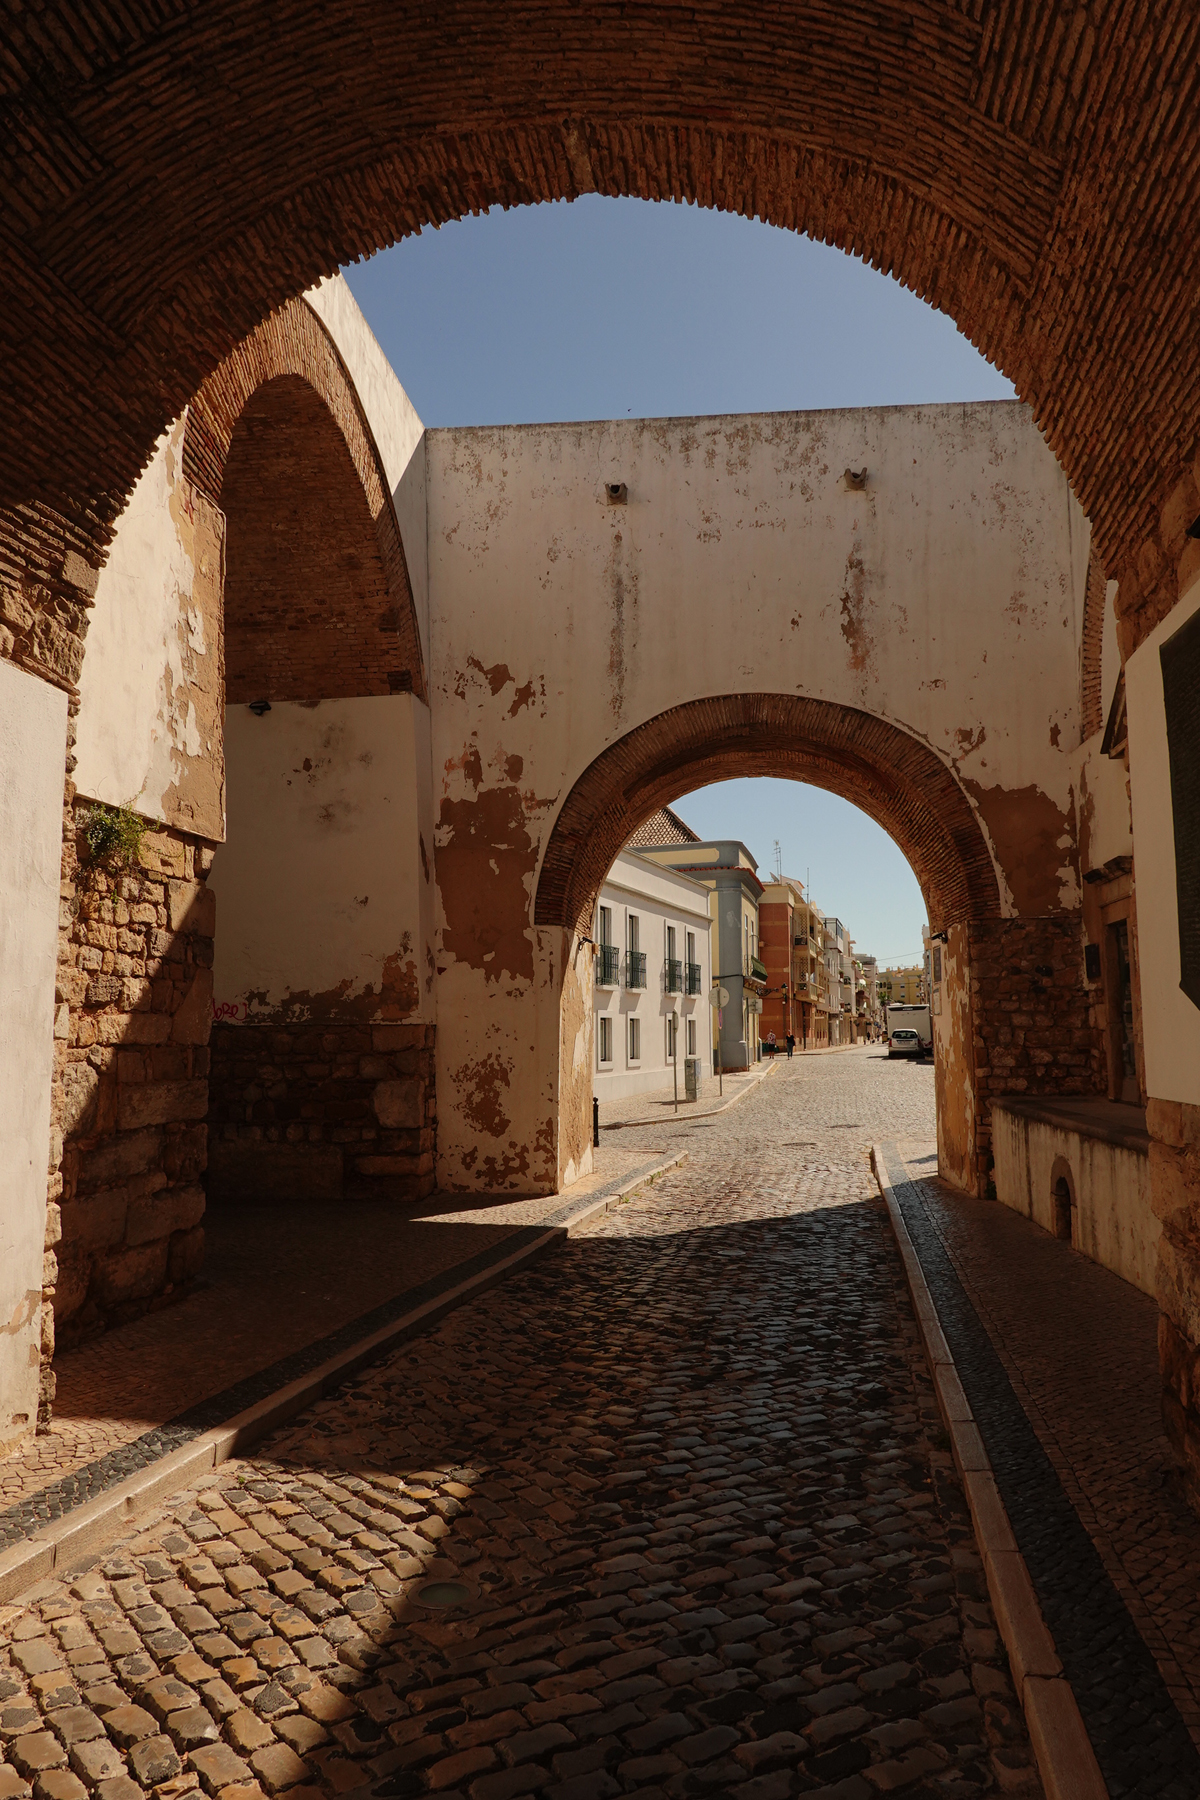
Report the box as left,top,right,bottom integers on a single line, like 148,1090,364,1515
0,1145,667,1552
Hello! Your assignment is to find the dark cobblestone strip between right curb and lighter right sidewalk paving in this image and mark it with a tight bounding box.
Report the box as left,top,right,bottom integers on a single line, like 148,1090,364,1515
889,1156,1200,1800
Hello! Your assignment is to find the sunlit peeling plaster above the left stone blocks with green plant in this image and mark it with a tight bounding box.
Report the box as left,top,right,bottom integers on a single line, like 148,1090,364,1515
76,419,225,842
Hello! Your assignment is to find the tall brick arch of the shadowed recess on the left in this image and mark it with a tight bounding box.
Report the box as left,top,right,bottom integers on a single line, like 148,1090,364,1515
184,301,425,700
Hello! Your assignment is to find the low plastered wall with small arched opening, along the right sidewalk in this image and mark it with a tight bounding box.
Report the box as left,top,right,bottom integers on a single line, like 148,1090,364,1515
991,1107,1162,1294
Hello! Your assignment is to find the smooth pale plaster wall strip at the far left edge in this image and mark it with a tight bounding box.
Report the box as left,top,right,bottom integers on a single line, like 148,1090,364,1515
0,661,67,1454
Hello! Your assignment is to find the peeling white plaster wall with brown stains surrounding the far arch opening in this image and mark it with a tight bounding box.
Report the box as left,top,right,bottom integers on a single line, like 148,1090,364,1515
426,403,1088,1190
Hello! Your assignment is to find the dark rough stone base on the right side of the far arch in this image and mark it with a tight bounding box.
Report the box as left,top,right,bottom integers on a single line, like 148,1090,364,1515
968,913,1105,1193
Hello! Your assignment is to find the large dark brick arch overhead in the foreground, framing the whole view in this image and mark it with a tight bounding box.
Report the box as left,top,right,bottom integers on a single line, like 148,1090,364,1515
0,0,1200,676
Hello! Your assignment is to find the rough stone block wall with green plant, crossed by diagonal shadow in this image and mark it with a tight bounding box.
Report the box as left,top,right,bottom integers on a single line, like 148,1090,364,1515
52,796,214,1360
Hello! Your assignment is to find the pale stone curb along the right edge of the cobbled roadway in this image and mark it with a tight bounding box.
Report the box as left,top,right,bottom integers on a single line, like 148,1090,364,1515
871,1143,1108,1800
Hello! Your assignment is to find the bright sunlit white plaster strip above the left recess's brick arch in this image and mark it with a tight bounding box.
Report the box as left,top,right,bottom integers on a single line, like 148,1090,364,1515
304,275,430,670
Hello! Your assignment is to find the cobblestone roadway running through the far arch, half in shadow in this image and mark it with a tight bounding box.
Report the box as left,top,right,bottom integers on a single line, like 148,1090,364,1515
0,1057,1040,1800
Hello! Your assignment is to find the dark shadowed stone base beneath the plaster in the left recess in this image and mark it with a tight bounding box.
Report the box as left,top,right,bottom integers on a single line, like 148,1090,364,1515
209,1021,435,1201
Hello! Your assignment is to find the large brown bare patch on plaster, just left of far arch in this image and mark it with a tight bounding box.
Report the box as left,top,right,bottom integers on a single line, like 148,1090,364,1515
435,785,538,981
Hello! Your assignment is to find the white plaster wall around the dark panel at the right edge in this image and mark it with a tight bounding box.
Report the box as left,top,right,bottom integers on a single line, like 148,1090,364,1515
1124,583,1200,1105
